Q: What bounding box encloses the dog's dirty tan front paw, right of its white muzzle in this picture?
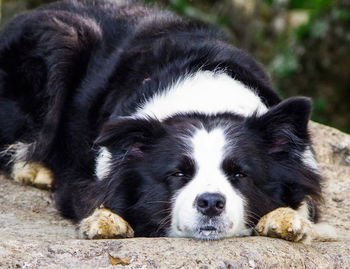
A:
[255,207,314,243]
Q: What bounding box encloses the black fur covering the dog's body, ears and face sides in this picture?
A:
[0,0,320,236]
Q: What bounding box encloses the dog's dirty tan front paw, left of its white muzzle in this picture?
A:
[79,208,134,239]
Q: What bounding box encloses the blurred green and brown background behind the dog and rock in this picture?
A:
[0,0,350,132]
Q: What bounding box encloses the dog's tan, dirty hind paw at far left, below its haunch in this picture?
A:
[11,162,53,189]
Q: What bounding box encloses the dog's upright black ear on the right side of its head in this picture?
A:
[246,97,312,154]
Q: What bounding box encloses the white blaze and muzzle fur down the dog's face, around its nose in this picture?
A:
[169,129,250,239]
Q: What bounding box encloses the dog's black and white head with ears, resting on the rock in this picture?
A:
[97,98,320,239]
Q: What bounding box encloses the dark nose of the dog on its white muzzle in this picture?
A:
[196,192,226,217]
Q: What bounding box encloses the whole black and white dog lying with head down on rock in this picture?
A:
[0,0,330,241]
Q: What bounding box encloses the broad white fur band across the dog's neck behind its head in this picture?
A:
[134,71,267,120]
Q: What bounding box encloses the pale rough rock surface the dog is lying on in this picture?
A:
[0,123,350,269]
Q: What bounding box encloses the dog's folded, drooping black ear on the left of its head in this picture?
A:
[95,118,166,156]
